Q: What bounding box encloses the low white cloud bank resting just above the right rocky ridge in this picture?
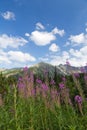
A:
[42,46,87,67]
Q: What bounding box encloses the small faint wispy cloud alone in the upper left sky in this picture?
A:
[1,11,15,20]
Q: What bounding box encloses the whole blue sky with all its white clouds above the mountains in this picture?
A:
[0,0,87,68]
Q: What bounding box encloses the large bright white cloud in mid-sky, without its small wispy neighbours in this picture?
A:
[30,31,56,46]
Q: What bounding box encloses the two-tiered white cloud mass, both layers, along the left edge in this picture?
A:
[0,34,36,68]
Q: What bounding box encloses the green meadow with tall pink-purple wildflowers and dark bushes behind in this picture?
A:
[0,67,87,130]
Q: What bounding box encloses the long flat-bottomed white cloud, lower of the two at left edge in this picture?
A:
[0,49,36,68]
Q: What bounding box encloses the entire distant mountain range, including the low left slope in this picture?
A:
[0,62,87,77]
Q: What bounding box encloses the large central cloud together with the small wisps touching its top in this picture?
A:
[27,22,65,46]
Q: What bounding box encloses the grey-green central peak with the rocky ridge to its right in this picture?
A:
[30,62,87,76]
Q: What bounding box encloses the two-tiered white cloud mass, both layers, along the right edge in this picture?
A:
[49,28,87,67]
